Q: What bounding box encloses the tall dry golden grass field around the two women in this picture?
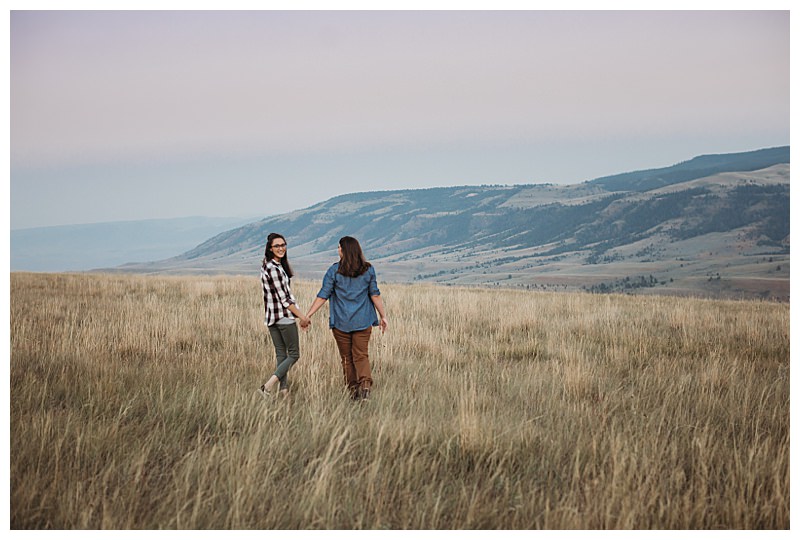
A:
[10,274,789,529]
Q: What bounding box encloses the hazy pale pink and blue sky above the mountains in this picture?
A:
[10,7,790,228]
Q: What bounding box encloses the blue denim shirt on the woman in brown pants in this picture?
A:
[317,263,381,332]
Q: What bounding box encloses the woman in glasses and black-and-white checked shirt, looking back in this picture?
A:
[261,233,311,396]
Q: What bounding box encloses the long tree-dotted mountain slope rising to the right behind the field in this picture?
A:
[118,147,789,299]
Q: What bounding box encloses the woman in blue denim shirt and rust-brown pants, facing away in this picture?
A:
[306,236,389,400]
